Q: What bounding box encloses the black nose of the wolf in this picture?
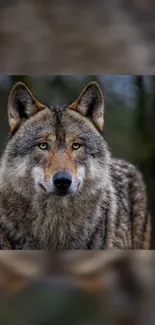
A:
[53,172,72,191]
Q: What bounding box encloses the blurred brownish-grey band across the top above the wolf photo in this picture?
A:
[0,0,155,74]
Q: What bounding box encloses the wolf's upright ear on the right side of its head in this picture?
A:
[70,82,104,131]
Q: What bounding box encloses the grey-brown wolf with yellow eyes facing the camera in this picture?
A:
[0,81,151,250]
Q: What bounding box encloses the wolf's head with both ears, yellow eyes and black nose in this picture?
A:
[2,82,109,197]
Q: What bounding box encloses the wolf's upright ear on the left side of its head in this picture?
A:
[8,82,44,132]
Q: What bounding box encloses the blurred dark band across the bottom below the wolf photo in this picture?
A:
[0,251,155,325]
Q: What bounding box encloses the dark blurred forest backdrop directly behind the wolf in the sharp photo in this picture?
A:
[0,75,155,249]
